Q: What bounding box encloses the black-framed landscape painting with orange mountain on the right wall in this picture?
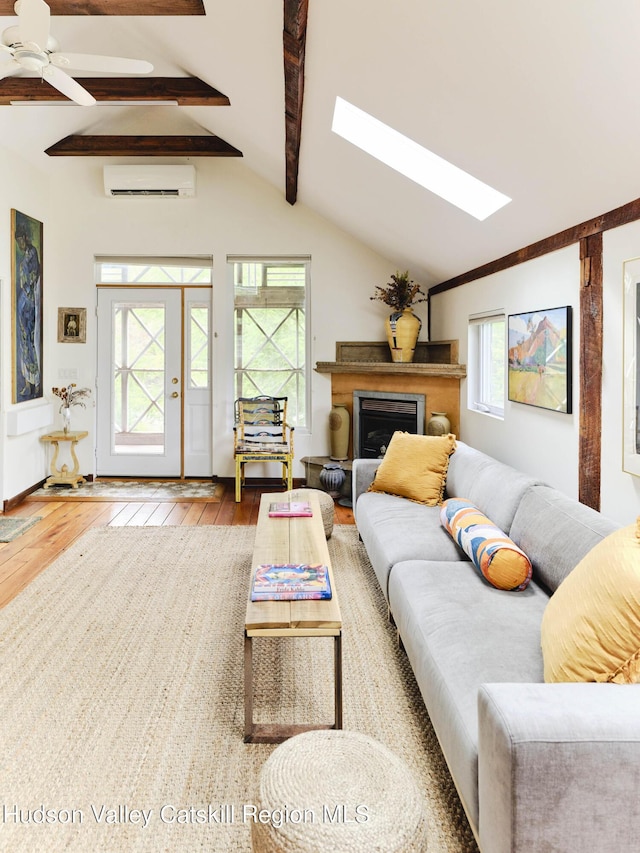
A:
[508,305,572,414]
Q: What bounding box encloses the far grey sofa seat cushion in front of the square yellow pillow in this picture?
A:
[356,492,469,599]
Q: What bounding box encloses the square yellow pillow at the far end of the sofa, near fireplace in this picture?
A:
[369,432,456,506]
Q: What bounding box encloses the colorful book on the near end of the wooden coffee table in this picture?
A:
[251,563,331,601]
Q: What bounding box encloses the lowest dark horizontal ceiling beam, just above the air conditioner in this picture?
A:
[45,134,242,157]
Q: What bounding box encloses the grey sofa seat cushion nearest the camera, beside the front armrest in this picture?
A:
[389,560,549,827]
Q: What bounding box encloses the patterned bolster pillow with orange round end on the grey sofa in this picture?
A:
[440,498,531,590]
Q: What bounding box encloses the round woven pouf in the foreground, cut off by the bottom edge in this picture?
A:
[251,729,427,853]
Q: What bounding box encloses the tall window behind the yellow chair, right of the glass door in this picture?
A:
[229,258,309,427]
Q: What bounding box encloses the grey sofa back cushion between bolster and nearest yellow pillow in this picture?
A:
[509,485,619,591]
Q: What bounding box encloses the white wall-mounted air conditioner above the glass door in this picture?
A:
[104,165,196,198]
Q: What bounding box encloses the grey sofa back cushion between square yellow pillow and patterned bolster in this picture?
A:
[445,441,539,536]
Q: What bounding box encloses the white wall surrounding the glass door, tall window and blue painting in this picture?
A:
[0,158,395,498]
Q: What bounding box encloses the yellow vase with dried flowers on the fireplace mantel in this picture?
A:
[370,270,427,362]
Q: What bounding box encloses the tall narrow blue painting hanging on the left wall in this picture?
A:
[11,210,43,403]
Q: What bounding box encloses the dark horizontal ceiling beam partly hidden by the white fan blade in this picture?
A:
[0,77,230,107]
